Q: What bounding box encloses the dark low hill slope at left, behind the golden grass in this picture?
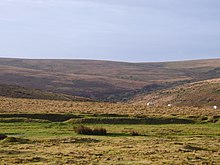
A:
[0,84,92,102]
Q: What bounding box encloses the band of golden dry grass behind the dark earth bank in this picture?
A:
[0,97,220,116]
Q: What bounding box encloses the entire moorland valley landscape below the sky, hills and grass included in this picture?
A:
[0,59,220,165]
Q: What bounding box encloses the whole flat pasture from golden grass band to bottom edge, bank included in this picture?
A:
[0,98,220,165]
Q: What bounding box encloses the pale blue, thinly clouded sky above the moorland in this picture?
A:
[0,0,220,62]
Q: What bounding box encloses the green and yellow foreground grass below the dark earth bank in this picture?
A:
[0,122,220,164]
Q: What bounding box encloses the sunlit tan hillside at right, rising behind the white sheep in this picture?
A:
[130,78,220,107]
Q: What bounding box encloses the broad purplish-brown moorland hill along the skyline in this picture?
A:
[0,58,220,101]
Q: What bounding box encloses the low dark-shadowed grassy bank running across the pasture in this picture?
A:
[0,113,220,124]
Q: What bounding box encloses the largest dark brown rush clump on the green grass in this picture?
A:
[74,125,107,135]
